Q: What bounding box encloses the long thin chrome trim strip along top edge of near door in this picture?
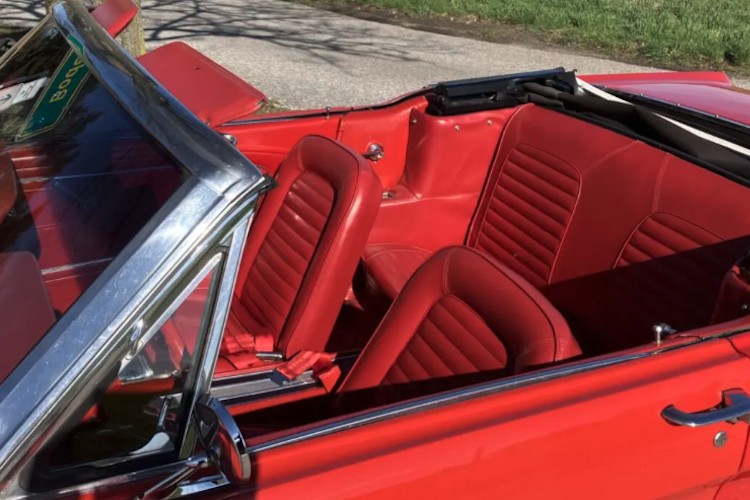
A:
[248,337,713,454]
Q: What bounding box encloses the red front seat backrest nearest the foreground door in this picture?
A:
[339,247,581,391]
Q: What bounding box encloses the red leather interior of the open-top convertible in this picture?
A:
[0,72,750,472]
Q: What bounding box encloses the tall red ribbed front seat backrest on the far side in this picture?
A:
[235,136,382,355]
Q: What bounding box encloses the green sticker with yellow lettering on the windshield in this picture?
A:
[18,50,89,139]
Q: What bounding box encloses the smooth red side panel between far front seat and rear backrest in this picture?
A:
[365,109,516,254]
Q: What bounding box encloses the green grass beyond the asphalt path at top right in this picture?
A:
[303,0,750,74]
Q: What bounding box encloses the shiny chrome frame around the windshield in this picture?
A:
[0,0,270,484]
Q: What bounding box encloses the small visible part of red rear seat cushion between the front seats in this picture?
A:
[362,245,432,300]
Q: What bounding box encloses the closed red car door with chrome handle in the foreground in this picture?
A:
[243,332,750,499]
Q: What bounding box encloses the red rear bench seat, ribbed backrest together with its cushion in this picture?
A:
[364,105,750,350]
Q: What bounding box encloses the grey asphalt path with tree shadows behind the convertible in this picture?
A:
[5,0,750,108]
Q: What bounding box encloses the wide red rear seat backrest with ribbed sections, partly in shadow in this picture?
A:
[467,106,750,354]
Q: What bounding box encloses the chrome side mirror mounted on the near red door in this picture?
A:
[139,396,250,500]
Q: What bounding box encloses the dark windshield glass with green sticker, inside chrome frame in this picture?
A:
[0,20,186,382]
